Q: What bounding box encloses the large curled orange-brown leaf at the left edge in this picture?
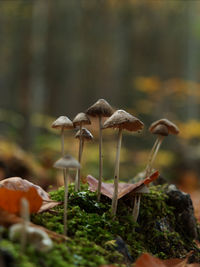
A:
[0,177,60,214]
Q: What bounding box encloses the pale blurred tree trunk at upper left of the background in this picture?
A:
[24,0,48,149]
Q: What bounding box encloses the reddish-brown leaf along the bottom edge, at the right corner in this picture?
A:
[133,253,200,267]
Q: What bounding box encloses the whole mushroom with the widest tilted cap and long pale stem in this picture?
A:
[103,110,144,215]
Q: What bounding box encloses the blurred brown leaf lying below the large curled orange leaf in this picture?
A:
[0,209,69,242]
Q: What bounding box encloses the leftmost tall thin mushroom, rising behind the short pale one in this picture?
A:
[51,116,74,187]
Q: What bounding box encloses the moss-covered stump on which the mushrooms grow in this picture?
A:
[0,185,200,267]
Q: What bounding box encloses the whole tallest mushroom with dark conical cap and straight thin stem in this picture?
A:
[86,99,113,201]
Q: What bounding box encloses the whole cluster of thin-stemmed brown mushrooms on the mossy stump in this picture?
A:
[52,99,179,234]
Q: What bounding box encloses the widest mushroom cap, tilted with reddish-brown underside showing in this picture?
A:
[103,109,144,132]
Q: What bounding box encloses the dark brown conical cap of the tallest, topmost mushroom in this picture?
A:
[85,99,113,117]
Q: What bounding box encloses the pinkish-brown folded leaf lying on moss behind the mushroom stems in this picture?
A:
[87,171,159,199]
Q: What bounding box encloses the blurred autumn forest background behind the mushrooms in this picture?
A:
[0,0,200,218]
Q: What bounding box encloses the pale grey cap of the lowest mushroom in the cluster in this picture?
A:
[53,155,81,169]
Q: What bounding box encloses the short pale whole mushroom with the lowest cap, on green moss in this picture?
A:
[54,155,80,235]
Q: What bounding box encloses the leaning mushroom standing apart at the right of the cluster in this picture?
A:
[145,119,179,177]
